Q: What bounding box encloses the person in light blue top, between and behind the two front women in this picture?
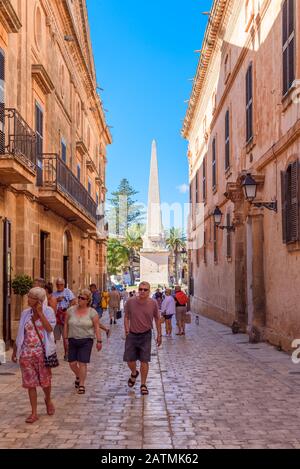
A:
[53,278,76,361]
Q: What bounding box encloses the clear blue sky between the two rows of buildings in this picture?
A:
[87,0,212,221]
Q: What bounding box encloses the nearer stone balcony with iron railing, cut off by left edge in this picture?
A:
[0,109,36,185]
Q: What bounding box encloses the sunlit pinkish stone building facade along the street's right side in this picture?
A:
[182,0,300,350]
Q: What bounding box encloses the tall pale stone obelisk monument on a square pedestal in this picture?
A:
[140,140,169,286]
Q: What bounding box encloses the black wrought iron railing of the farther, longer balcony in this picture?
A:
[38,153,97,223]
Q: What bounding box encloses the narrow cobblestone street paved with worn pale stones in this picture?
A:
[0,312,300,449]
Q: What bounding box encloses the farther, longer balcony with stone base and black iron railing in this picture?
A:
[38,154,97,231]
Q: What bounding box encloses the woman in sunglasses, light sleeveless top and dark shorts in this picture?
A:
[64,289,102,394]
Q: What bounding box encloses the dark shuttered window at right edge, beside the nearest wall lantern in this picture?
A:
[281,161,300,244]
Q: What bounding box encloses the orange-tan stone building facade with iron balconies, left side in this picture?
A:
[0,0,111,343]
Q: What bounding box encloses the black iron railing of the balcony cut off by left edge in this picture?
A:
[0,108,37,171]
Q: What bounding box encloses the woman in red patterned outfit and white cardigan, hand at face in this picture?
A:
[12,287,58,423]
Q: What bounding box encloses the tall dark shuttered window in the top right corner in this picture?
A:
[282,0,295,95]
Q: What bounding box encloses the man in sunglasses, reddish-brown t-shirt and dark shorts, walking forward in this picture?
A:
[124,282,161,396]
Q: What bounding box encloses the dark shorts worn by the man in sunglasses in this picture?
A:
[123,329,152,363]
